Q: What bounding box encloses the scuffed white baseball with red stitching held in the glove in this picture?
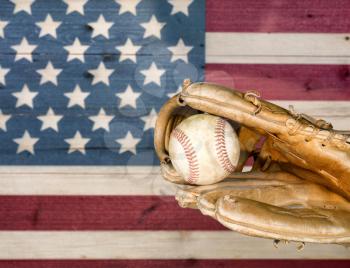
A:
[169,114,240,185]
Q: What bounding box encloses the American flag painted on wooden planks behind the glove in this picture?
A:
[0,0,350,268]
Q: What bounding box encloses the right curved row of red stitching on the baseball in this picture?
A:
[215,118,236,173]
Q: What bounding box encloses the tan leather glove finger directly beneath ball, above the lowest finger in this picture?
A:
[189,180,350,222]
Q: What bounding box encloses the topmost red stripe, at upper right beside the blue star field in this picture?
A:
[206,0,350,33]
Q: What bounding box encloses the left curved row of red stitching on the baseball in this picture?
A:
[171,129,199,183]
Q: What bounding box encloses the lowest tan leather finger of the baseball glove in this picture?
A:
[216,195,350,243]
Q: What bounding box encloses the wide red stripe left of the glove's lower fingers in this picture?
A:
[0,196,225,230]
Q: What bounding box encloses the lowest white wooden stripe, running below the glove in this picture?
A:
[0,231,350,260]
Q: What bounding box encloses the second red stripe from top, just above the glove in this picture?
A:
[206,64,350,100]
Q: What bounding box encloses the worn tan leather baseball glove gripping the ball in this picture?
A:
[154,80,350,244]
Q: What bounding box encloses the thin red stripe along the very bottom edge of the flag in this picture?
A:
[0,259,349,268]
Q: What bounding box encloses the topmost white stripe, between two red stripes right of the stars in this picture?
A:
[206,32,350,64]
